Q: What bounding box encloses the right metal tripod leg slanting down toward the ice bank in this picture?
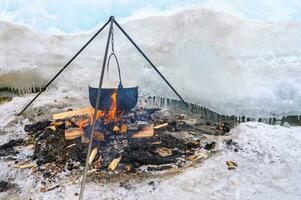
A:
[114,20,189,108]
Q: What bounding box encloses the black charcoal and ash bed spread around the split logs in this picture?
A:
[12,108,216,180]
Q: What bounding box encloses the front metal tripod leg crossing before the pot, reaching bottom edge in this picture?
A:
[79,16,114,200]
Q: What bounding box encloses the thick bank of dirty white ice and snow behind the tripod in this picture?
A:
[0,9,301,115]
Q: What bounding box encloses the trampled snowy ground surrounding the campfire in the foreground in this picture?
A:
[0,92,301,199]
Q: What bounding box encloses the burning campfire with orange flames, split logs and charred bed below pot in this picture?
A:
[12,91,229,184]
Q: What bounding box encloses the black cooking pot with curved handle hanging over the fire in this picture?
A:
[89,53,138,112]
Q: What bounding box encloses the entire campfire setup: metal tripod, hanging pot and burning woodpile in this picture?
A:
[7,16,229,199]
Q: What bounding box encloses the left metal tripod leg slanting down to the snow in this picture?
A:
[18,20,110,116]
